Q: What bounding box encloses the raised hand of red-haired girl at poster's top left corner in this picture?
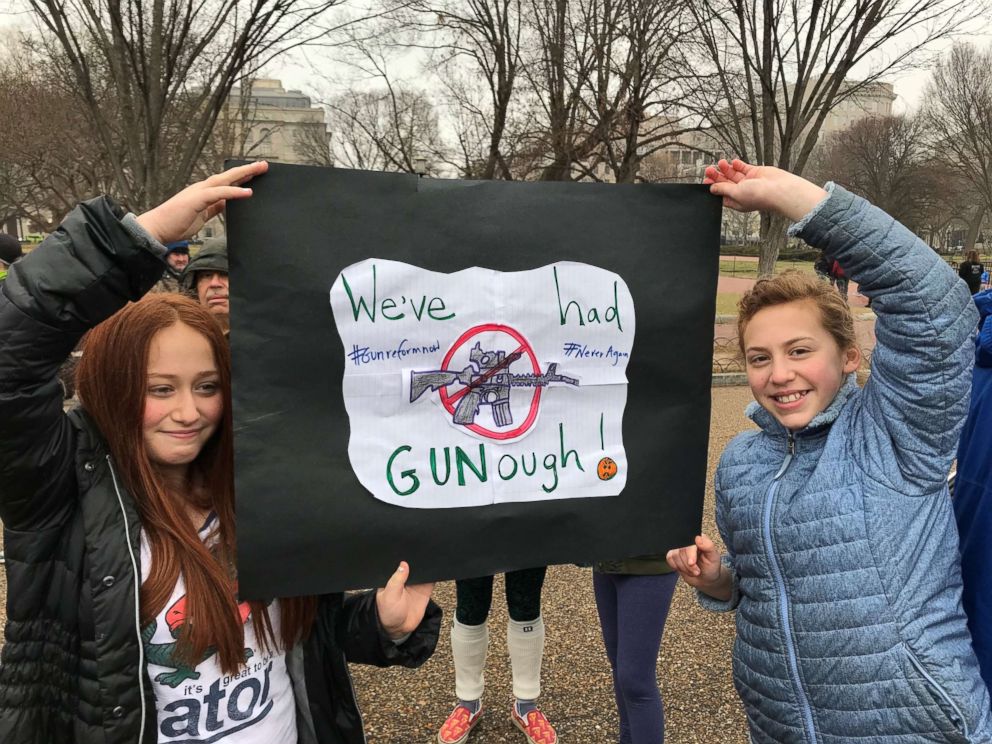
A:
[138,160,269,243]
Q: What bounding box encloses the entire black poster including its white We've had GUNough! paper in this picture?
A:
[228,166,720,597]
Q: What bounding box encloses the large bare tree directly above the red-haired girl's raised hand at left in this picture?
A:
[29,0,356,209]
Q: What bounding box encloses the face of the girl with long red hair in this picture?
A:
[142,322,224,477]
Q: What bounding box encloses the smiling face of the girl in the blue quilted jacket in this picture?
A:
[744,300,861,431]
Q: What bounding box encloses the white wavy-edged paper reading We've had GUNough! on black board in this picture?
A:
[330,258,634,508]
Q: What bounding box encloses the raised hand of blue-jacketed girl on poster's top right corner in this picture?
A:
[703,159,827,221]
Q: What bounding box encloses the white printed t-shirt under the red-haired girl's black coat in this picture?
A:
[141,517,296,744]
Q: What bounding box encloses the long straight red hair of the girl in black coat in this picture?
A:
[76,294,316,674]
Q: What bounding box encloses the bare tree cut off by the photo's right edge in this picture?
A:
[924,44,992,250]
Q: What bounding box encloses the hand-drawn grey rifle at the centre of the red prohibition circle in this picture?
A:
[410,343,579,427]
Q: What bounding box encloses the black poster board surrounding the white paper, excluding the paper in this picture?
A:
[227,165,721,597]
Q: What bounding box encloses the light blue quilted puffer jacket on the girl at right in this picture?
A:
[699,186,992,744]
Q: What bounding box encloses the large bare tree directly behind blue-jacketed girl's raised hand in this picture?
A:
[689,0,988,276]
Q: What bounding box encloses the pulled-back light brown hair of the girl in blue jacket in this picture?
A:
[737,270,857,354]
